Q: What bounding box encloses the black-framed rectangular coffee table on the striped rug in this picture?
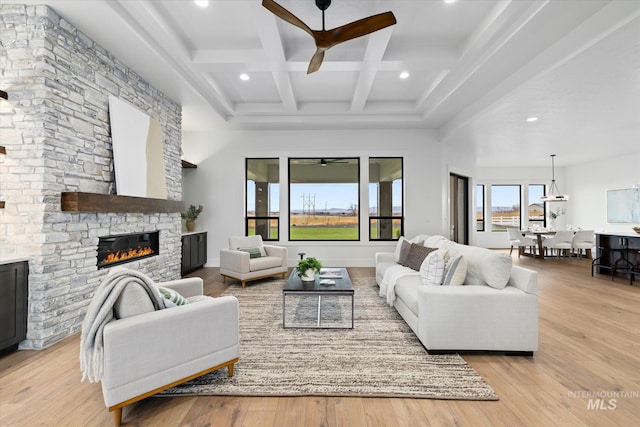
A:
[282,268,354,329]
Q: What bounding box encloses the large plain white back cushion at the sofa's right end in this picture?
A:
[455,245,513,289]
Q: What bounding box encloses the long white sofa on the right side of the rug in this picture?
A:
[375,235,538,355]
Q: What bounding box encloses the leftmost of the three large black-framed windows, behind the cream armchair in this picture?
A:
[245,159,280,240]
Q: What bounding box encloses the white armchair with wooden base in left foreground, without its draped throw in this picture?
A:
[102,278,239,426]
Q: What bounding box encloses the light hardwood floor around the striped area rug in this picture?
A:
[0,254,640,427]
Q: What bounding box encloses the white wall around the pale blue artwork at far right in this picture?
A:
[566,153,640,233]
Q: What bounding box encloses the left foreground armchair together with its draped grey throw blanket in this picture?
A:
[80,269,240,426]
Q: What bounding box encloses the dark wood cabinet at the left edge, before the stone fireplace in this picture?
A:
[0,261,29,355]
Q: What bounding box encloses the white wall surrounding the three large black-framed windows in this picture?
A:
[183,130,448,266]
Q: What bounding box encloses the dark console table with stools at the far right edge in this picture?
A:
[594,232,640,282]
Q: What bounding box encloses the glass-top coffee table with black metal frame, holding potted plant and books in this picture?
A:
[282,268,354,329]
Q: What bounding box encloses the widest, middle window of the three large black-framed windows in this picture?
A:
[289,158,360,240]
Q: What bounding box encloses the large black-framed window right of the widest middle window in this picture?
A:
[369,157,404,240]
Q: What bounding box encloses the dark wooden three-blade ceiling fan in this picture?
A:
[262,0,396,74]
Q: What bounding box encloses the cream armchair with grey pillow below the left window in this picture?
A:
[220,235,288,288]
